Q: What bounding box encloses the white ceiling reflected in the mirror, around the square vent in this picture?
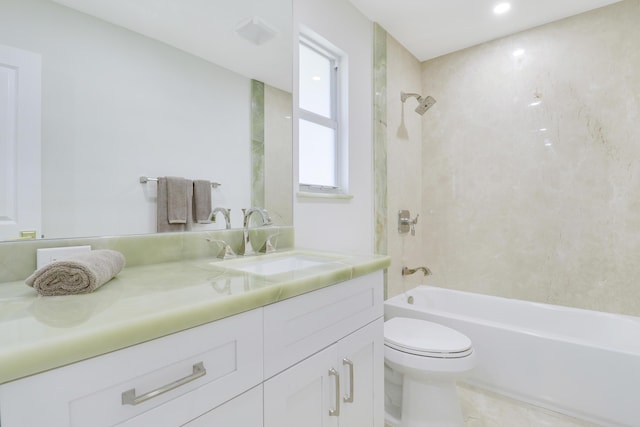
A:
[52,0,293,92]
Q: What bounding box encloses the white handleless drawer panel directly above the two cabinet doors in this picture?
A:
[264,272,383,378]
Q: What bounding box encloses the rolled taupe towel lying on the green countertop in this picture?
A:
[25,249,125,296]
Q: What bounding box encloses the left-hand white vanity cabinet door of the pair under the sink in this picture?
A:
[264,345,340,427]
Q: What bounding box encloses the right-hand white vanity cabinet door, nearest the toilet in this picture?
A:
[337,319,384,427]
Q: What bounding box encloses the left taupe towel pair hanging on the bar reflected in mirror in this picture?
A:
[156,177,193,233]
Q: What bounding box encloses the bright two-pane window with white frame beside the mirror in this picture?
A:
[298,37,343,193]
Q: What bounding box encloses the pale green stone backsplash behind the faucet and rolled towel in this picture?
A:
[0,226,294,283]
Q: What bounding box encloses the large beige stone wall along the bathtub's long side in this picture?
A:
[418,0,640,315]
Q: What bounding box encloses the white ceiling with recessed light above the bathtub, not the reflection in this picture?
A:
[350,0,620,61]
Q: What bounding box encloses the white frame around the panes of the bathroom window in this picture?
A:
[297,34,346,195]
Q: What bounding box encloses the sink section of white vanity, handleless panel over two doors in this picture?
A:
[264,273,384,427]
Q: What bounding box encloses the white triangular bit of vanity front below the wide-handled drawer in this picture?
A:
[184,385,262,427]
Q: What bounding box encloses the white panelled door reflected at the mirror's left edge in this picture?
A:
[0,45,41,241]
